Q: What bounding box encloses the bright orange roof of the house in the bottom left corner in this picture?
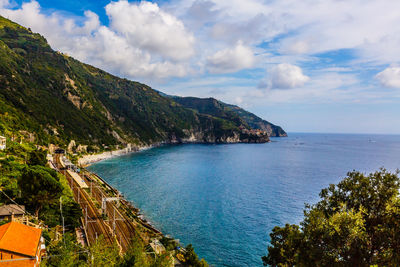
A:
[0,222,42,257]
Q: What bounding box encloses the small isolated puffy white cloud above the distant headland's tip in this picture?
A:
[268,63,310,89]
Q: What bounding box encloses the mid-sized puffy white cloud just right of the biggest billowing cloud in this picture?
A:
[207,42,255,73]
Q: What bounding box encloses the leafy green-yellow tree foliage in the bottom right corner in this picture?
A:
[263,169,400,266]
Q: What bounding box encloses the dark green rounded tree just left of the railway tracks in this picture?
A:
[18,166,63,217]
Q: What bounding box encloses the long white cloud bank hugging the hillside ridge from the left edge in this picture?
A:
[0,0,194,79]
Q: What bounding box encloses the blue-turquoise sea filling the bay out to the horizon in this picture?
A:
[89,133,400,266]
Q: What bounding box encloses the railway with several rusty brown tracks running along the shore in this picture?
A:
[55,155,160,253]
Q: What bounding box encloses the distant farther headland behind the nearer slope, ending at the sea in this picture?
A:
[172,96,287,137]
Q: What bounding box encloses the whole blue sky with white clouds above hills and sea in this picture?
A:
[0,0,400,134]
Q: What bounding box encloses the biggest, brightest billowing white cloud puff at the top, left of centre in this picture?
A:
[106,1,194,61]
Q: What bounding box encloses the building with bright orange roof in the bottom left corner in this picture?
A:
[0,222,45,267]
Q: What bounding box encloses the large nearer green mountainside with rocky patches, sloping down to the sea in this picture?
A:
[0,17,284,149]
